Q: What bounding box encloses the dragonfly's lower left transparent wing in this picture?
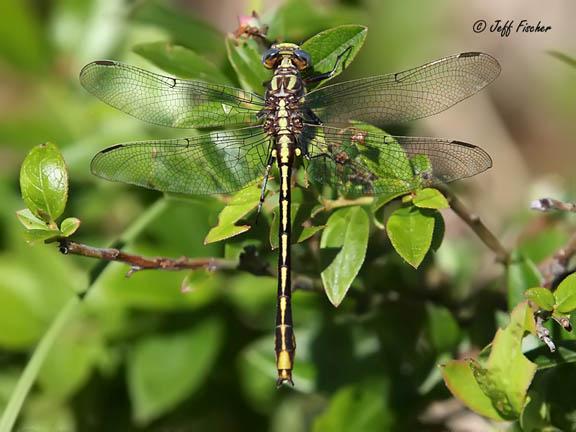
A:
[91,126,270,195]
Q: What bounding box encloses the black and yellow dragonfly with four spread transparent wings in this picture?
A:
[80,43,500,386]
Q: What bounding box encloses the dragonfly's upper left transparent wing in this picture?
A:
[80,60,264,128]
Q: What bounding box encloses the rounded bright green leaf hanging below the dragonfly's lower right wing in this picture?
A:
[386,206,435,268]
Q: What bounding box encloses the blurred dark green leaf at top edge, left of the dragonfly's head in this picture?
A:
[131,2,224,60]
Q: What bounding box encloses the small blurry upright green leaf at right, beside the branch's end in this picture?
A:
[506,251,541,310]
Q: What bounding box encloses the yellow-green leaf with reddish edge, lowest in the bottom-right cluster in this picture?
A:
[442,360,504,420]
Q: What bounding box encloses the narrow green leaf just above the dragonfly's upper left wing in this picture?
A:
[132,42,230,84]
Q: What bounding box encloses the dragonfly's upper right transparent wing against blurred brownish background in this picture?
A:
[305,52,500,125]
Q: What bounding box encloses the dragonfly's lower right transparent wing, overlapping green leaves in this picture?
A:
[301,122,492,196]
